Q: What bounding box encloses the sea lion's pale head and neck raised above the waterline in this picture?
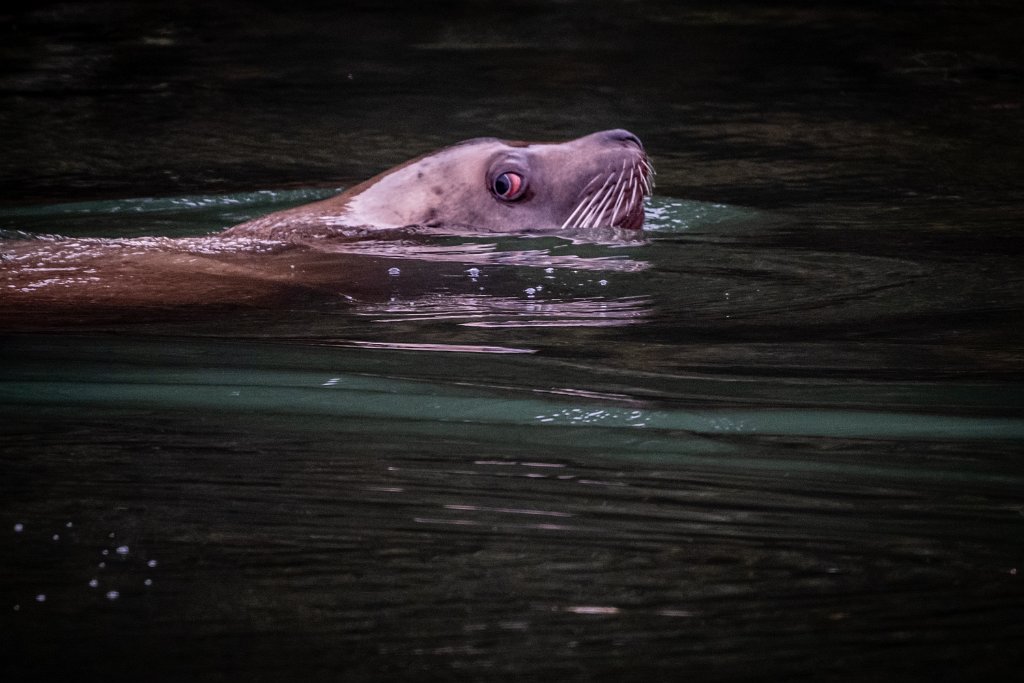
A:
[221,129,653,240]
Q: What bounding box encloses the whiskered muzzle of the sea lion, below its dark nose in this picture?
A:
[560,150,654,230]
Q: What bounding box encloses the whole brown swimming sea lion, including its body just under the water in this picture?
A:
[0,130,653,329]
